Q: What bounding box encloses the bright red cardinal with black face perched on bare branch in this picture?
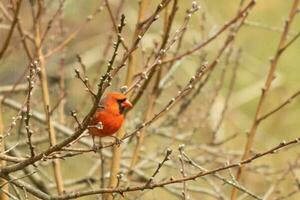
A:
[88,92,132,147]
